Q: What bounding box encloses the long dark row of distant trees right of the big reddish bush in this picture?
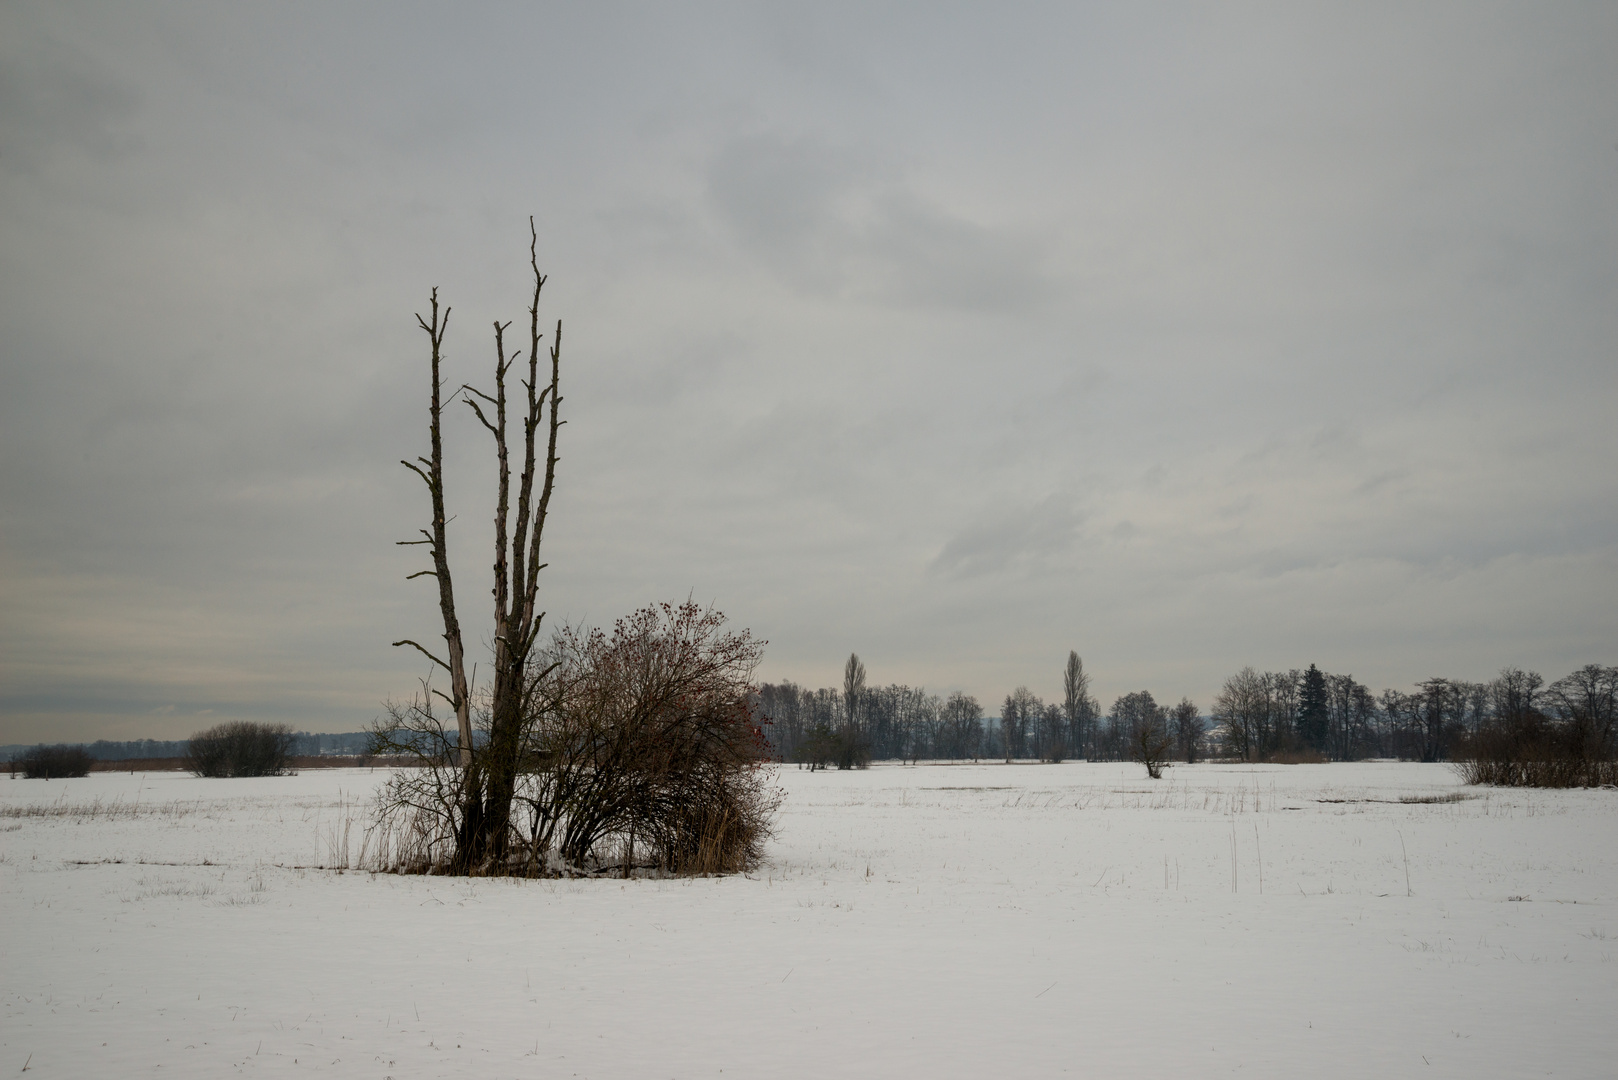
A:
[756,653,1618,780]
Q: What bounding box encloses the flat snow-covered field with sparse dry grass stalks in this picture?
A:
[0,764,1618,1078]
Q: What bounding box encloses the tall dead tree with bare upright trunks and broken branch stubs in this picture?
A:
[393,219,561,873]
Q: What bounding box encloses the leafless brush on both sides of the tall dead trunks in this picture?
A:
[371,602,778,876]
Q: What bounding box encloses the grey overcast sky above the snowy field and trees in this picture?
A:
[0,0,1618,742]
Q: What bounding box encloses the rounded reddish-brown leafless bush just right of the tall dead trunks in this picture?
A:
[519,602,775,873]
